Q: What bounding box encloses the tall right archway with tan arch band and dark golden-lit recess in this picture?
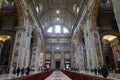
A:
[91,0,120,70]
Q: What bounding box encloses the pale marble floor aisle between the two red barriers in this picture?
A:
[45,70,72,80]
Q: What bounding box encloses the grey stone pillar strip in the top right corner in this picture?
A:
[112,0,120,32]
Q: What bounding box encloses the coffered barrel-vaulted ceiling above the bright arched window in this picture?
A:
[35,0,83,37]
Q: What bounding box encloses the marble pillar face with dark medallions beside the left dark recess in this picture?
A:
[10,27,24,73]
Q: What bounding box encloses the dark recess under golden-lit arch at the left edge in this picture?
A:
[0,31,15,73]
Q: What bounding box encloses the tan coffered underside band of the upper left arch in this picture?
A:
[13,0,25,26]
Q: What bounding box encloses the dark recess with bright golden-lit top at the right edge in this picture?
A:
[100,31,120,72]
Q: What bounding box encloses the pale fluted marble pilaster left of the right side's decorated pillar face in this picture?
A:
[84,26,97,69]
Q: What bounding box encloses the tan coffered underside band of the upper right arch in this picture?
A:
[91,0,102,27]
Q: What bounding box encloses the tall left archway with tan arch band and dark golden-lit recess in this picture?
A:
[0,0,24,72]
